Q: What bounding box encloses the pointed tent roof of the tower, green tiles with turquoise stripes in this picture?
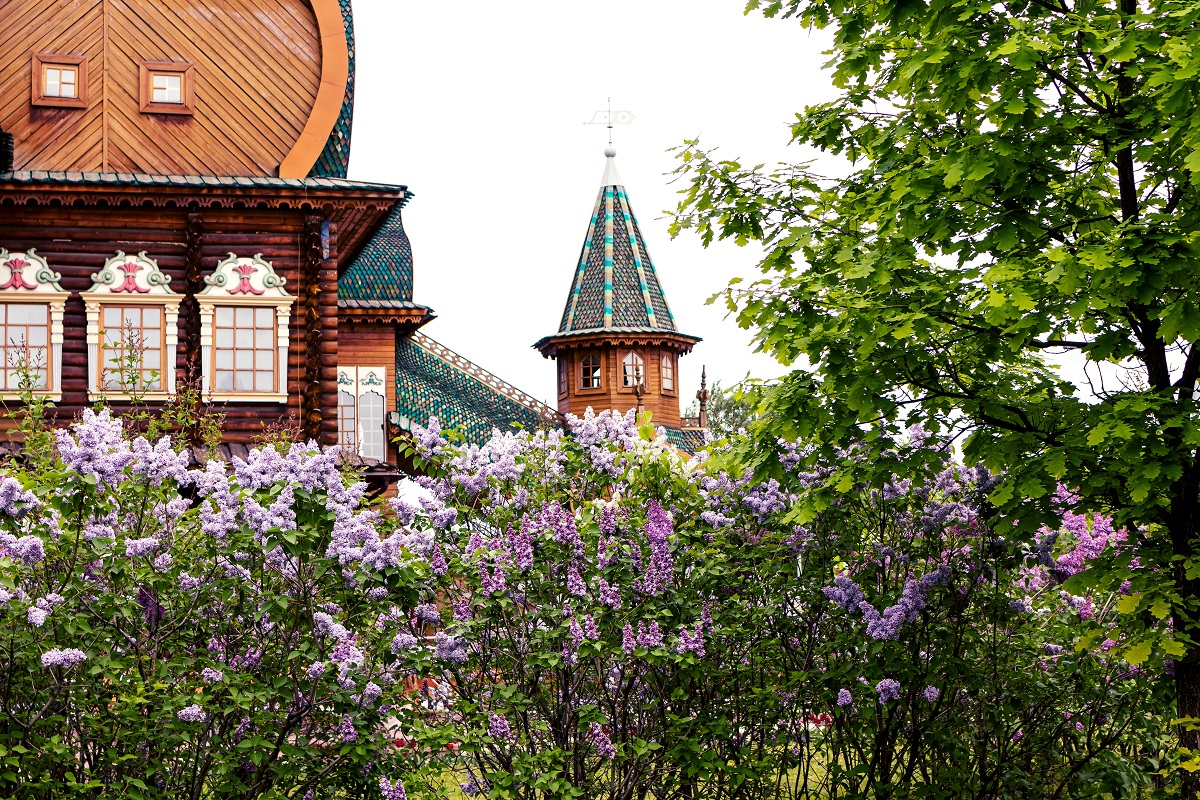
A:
[558,146,677,336]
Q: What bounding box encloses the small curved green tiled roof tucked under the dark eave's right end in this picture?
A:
[337,203,418,308]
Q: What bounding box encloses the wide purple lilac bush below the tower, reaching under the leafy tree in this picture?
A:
[392,413,1170,800]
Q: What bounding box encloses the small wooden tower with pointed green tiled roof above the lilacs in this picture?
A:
[534,146,700,431]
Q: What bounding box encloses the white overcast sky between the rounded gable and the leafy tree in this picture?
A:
[350,0,833,407]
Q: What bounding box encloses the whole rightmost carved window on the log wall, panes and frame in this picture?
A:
[196,254,295,403]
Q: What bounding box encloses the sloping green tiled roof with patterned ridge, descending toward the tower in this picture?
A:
[396,332,560,444]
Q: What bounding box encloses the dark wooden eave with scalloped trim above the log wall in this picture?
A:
[0,173,408,272]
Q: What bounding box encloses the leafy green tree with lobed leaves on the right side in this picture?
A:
[674,0,1200,777]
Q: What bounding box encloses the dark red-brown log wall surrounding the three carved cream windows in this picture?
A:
[0,205,338,444]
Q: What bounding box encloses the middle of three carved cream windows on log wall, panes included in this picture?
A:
[83,251,181,401]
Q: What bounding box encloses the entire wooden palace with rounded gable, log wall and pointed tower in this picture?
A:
[0,0,697,463]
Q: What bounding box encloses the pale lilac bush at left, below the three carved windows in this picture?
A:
[0,411,431,799]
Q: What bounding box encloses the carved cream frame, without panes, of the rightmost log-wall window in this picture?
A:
[196,253,296,403]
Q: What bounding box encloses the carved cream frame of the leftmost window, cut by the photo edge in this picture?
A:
[0,247,71,401]
